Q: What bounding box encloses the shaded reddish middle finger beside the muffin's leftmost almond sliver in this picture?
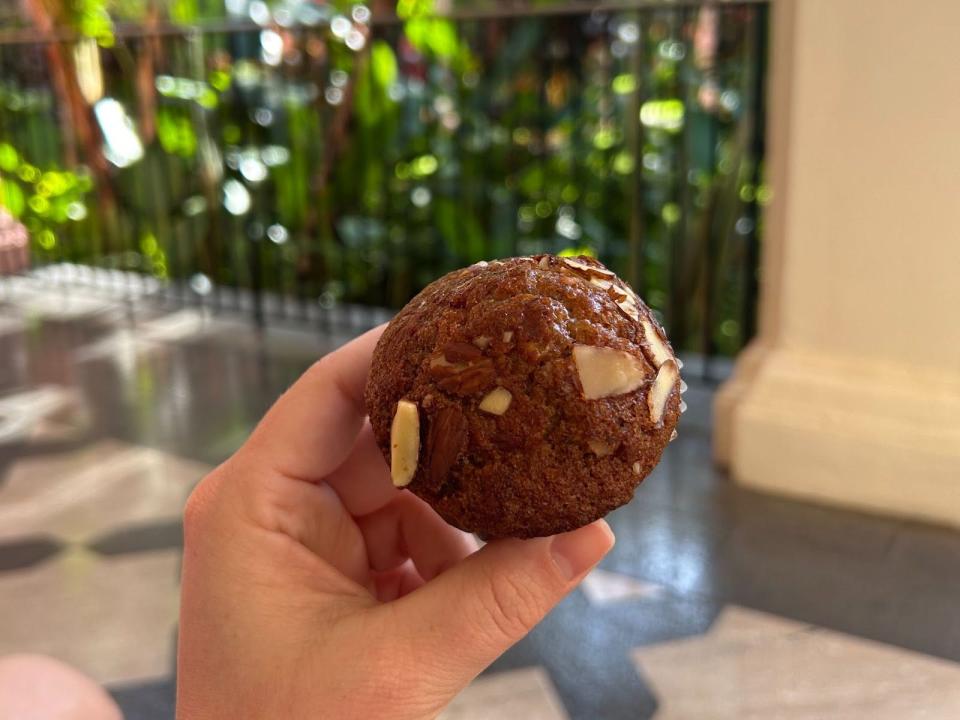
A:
[326,422,400,516]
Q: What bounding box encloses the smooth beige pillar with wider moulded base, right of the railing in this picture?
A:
[714,0,960,526]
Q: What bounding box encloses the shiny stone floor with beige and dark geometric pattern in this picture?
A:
[0,284,960,720]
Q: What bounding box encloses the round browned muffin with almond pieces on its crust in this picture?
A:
[366,255,681,538]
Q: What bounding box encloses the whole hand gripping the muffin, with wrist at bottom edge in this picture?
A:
[177,330,613,720]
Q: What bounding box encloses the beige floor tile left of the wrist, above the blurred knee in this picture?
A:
[0,548,180,683]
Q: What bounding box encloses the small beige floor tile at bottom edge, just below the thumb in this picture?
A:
[438,667,567,720]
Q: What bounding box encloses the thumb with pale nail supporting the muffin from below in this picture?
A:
[393,520,614,697]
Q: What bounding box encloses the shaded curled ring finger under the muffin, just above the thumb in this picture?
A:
[356,492,477,580]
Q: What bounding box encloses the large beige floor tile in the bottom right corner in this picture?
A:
[633,606,960,720]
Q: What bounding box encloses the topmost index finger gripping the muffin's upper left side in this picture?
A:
[239,326,384,481]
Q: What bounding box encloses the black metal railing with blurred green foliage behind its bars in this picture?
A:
[0,3,769,372]
